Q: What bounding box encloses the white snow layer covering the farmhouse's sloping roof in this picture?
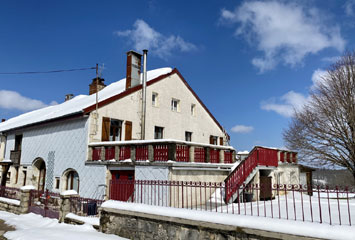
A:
[0,68,172,132]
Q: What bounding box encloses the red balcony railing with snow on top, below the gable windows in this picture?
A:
[88,139,235,164]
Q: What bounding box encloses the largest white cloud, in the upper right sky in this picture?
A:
[221,1,345,72]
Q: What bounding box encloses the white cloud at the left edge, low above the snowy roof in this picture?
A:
[0,90,57,111]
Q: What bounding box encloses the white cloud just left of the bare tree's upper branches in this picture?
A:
[261,91,308,117]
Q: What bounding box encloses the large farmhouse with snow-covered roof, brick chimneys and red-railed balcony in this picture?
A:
[0,51,235,198]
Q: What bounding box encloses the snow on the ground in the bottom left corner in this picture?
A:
[0,211,126,240]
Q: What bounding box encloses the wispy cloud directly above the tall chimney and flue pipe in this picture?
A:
[114,19,197,59]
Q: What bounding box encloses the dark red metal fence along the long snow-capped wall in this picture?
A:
[110,180,355,226]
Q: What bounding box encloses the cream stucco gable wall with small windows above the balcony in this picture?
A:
[90,74,224,144]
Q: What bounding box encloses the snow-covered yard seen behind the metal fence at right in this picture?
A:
[207,189,355,228]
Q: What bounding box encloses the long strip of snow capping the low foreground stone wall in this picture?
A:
[102,200,355,240]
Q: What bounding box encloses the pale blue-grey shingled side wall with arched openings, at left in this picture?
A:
[5,118,105,198]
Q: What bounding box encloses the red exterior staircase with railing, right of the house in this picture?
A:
[224,146,280,203]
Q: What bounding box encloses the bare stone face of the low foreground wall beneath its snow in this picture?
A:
[100,207,315,240]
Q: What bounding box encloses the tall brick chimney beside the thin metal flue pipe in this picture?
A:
[126,50,142,90]
